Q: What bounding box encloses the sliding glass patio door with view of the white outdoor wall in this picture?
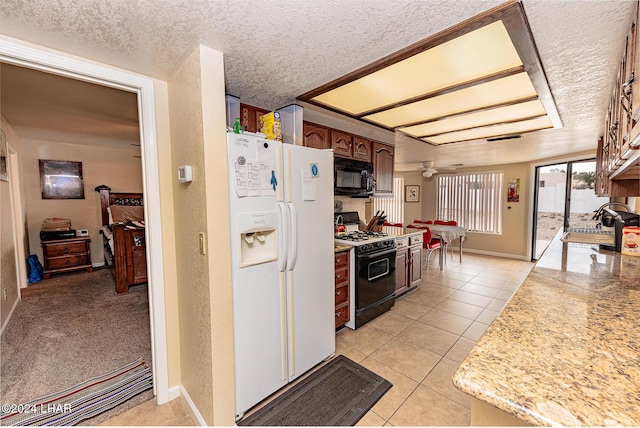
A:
[531,159,609,261]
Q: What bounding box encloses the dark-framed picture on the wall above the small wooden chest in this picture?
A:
[38,159,84,199]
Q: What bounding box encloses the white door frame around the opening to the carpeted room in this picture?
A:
[0,37,169,404]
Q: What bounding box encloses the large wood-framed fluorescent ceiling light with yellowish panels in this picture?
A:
[298,1,562,145]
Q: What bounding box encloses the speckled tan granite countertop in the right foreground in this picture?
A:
[453,233,640,426]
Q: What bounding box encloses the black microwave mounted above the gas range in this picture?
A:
[333,156,374,198]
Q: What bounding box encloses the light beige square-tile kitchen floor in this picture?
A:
[102,254,533,426]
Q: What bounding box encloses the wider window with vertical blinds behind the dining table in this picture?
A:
[436,172,503,234]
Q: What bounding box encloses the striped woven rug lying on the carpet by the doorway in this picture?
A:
[0,358,153,426]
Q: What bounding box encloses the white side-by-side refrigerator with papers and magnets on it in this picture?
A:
[227,133,335,417]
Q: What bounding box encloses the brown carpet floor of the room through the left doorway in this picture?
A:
[0,269,153,425]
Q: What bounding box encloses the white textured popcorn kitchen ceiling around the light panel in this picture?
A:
[0,0,636,168]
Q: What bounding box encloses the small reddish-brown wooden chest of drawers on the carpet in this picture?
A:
[41,238,93,279]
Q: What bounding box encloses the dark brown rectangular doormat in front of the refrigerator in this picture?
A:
[238,355,393,426]
